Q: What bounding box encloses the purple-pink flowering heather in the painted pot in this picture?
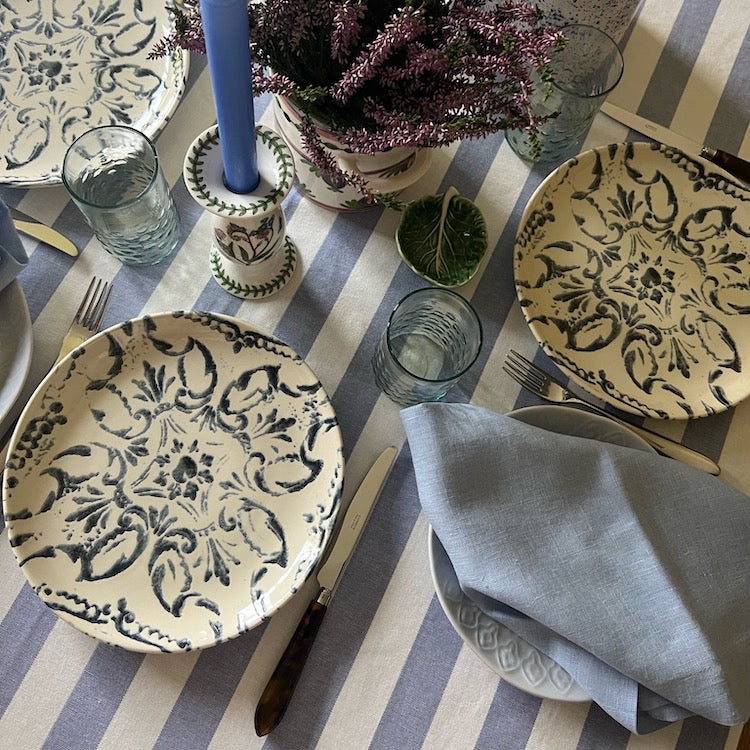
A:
[153,0,563,198]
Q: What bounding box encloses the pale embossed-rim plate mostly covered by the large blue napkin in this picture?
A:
[428,406,652,702]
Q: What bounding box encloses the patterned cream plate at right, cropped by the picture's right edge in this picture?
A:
[514,143,750,419]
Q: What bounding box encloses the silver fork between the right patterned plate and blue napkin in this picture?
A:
[503,349,721,475]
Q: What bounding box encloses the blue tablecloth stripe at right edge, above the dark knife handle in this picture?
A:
[706,25,750,154]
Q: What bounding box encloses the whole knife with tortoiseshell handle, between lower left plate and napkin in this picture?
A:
[255,446,396,737]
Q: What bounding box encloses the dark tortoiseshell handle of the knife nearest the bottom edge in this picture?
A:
[255,588,331,737]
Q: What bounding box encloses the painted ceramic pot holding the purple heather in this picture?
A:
[273,97,432,211]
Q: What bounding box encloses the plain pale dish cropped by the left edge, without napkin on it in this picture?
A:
[0,281,34,438]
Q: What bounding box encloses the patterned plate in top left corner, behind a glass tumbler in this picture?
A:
[0,0,189,186]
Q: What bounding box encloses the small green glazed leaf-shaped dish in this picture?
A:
[396,188,487,287]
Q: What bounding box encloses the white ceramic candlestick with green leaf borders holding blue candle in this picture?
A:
[183,125,297,299]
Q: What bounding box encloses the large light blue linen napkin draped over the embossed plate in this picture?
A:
[401,403,750,734]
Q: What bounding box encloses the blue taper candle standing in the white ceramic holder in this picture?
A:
[200,0,260,193]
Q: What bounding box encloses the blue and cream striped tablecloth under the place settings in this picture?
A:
[0,0,750,750]
